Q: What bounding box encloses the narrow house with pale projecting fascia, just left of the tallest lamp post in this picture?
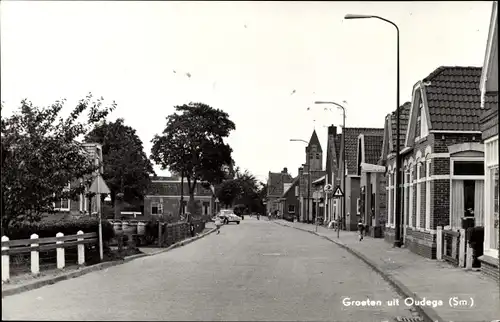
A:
[356,134,385,237]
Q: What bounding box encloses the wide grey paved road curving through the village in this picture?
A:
[2,218,418,322]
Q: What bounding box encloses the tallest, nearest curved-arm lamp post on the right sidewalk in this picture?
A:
[344,14,402,247]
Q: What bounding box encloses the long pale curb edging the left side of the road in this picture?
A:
[2,228,217,298]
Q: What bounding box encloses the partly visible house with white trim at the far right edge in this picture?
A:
[479,1,500,280]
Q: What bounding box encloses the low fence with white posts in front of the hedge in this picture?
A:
[2,230,98,282]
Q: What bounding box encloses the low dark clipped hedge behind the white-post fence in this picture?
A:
[6,218,115,242]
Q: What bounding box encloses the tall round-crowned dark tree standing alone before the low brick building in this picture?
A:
[151,103,236,215]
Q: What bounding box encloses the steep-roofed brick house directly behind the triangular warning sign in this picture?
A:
[336,128,384,231]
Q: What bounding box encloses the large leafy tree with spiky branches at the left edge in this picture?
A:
[1,94,116,230]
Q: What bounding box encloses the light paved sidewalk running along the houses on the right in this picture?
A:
[275,220,500,322]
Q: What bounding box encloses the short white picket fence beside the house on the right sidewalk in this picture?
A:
[436,226,473,269]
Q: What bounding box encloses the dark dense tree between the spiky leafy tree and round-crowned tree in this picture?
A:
[85,119,154,204]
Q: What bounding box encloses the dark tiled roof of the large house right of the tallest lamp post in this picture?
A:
[420,66,482,131]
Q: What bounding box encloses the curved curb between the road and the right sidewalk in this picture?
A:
[275,222,444,322]
